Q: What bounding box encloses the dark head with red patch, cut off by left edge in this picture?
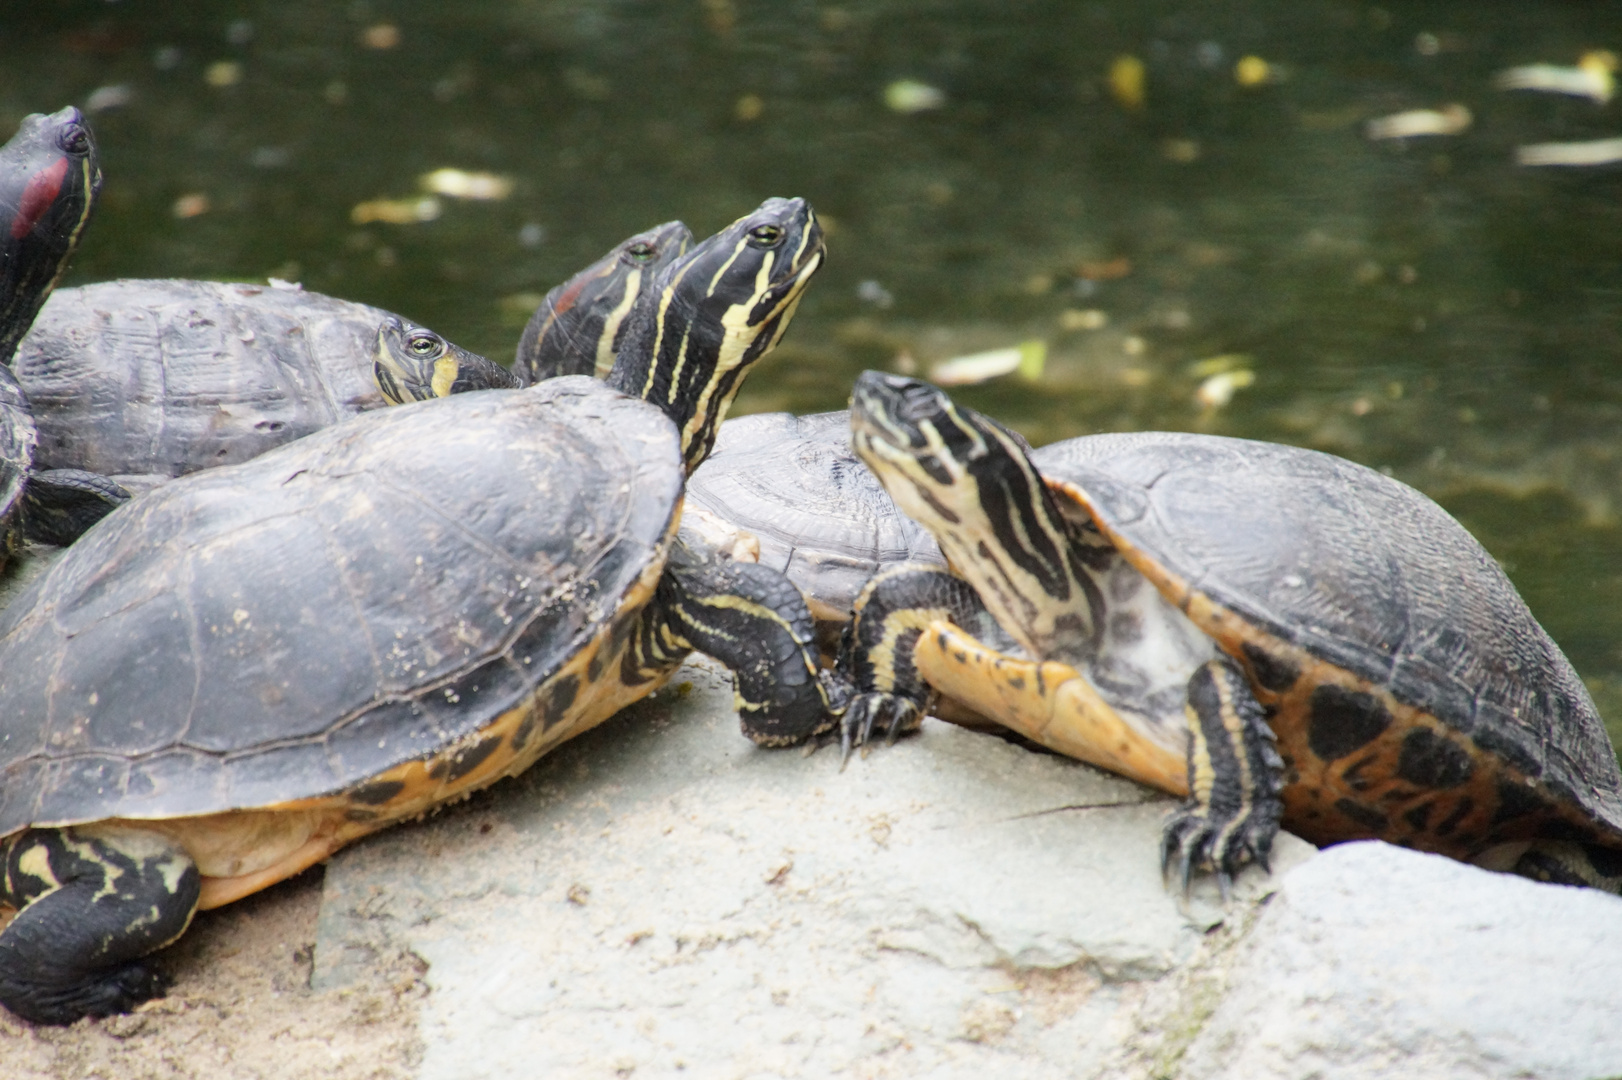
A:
[0,105,101,363]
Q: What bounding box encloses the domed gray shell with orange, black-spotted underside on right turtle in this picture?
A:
[1032,433,1622,846]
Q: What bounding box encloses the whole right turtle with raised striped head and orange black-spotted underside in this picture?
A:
[840,371,1622,892]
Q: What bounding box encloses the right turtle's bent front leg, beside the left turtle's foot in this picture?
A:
[835,563,1014,759]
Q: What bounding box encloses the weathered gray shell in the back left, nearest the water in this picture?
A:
[13,279,389,490]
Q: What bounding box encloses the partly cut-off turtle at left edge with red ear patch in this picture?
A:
[0,105,128,563]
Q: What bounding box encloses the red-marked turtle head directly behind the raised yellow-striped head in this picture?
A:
[513,221,693,386]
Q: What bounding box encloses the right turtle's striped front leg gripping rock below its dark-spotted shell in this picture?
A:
[1160,657,1285,900]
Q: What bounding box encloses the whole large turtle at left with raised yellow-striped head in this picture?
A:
[0,199,837,1023]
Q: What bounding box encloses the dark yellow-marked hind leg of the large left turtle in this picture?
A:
[0,825,201,1023]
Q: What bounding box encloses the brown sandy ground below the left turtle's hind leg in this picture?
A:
[0,869,427,1080]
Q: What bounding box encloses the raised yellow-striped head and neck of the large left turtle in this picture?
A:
[608,199,822,474]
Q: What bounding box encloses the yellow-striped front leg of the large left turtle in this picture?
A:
[647,540,837,746]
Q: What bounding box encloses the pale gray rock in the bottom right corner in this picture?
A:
[1178,843,1622,1080]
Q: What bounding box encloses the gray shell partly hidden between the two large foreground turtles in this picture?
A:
[686,412,946,619]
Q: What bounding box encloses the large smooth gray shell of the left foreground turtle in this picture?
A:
[0,378,683,835]
